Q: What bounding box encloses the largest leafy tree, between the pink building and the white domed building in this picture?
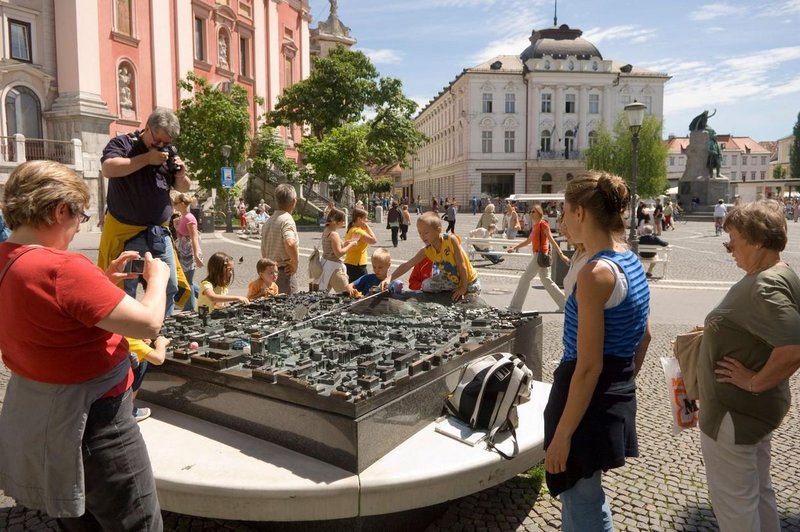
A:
[267,46,425,188]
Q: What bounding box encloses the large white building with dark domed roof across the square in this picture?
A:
[401,25,669,205]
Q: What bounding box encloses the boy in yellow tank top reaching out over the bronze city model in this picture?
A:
[381,212,481,301]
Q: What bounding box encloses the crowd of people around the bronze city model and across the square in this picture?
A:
[0,109,800,531]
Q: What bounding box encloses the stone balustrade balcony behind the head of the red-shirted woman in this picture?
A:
[0,134,83,173]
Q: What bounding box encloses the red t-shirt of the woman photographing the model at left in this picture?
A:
[0,242,133,395]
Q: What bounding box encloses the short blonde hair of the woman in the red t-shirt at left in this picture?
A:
[3,161,90,230]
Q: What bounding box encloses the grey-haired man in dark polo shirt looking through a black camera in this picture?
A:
[97,107,191,316]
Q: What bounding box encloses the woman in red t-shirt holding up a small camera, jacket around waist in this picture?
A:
[0,161,170,530]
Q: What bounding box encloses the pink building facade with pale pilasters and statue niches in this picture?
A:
[0,0,311,224]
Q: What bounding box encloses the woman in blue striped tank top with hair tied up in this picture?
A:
[544,172,650,532]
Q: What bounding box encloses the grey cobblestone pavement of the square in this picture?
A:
[0,217,800,532]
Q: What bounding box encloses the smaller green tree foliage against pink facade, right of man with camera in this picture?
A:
[175,72,250,196]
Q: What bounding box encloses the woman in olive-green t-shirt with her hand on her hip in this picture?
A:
[697,201,800,532]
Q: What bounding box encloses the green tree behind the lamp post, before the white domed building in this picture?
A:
[586,113,668,197]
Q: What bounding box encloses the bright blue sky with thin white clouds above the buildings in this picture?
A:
[309,0,800,141]
